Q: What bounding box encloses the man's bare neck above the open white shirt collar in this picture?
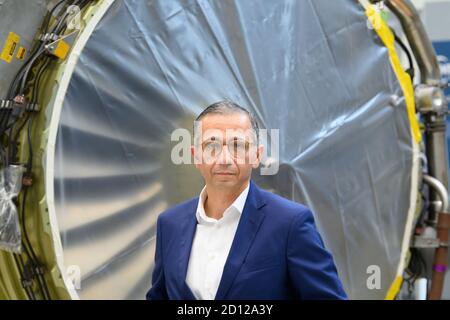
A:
[203,181,249,220]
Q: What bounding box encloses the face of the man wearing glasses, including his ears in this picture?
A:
[191,113,263,189]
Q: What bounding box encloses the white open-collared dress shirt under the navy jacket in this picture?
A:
[186,184,250,300]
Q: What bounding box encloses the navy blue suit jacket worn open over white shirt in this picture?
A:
[147,181,346,300]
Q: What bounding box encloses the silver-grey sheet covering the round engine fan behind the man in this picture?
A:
[54,0,415,299]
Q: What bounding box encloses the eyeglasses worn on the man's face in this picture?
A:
[202,137,252,159]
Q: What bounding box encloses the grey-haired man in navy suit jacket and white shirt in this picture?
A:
[147,101,346,300]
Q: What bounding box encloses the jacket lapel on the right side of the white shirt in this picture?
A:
[216,181,265,300]
